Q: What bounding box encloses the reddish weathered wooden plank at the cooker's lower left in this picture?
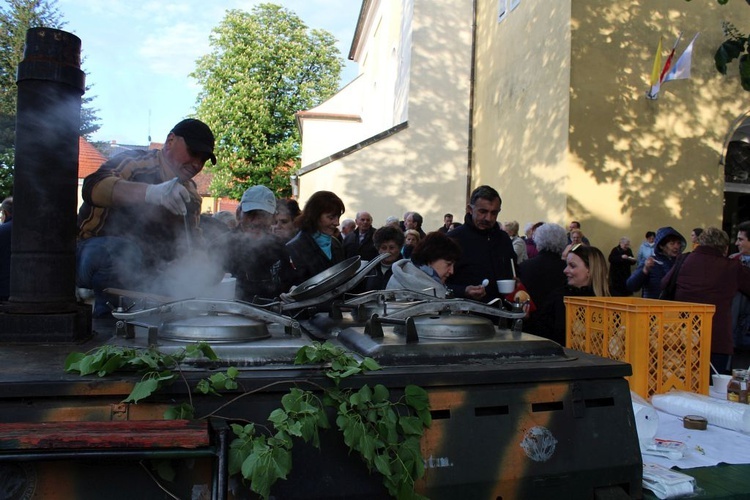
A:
[0,420,210,450]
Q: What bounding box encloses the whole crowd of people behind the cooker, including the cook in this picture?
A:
[0,119,750,372]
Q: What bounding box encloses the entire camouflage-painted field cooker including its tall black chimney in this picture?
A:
[0,28,642,500]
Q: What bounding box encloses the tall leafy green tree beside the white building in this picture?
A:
[191,4,343,199]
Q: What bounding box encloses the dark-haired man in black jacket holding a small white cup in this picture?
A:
[447,186,516,302]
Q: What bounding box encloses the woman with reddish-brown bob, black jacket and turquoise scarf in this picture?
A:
[286,191,344,284]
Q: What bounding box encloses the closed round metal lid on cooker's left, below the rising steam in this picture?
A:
[159,314,271,342]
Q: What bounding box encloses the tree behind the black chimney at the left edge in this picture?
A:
[0,0,99,197]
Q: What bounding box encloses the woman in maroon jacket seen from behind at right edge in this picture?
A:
[661,227,750,373]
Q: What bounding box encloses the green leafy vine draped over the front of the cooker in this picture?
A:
[65,342,431,499]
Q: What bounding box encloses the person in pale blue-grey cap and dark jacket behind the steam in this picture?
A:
[216,186,294,303]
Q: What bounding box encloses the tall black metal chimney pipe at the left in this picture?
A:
[0,28,91,341]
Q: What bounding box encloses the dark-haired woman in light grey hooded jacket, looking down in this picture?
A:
[386,232,461,299]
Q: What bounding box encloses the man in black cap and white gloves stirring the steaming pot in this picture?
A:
[76,118,216,318]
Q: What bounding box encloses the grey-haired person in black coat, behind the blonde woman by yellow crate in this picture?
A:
[518,223,568,344]
